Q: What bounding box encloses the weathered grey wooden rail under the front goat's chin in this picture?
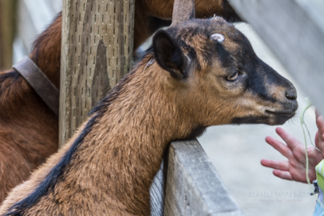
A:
[164,140,242,216]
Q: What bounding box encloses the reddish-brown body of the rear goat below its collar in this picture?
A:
[0,71,58,201]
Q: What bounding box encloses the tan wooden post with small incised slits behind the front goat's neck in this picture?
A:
[59,0,134,146]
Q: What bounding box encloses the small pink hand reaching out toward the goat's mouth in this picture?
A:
[261,126,324,183]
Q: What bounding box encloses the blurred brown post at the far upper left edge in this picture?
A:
[0,0,16,70]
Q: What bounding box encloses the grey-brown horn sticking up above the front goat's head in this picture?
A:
[171,0,195,25]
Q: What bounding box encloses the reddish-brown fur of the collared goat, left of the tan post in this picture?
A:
[0,13,61,203]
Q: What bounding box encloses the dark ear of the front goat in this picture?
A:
[153,30,188,79]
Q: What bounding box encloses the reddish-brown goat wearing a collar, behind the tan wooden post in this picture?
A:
[0,0,239,203]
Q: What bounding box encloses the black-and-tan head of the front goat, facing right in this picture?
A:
[153,17,297,126]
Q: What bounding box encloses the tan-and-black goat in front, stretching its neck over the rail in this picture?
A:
[0,11,297,215]
